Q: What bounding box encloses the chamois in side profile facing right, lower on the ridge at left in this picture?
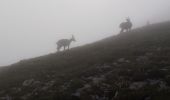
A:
[56,35,76,51]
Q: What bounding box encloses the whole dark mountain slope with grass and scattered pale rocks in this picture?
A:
[0,22,170,100]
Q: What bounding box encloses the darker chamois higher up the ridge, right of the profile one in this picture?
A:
[120,18,132,33]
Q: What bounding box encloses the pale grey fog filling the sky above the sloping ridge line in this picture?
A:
[0,0,170,66]
